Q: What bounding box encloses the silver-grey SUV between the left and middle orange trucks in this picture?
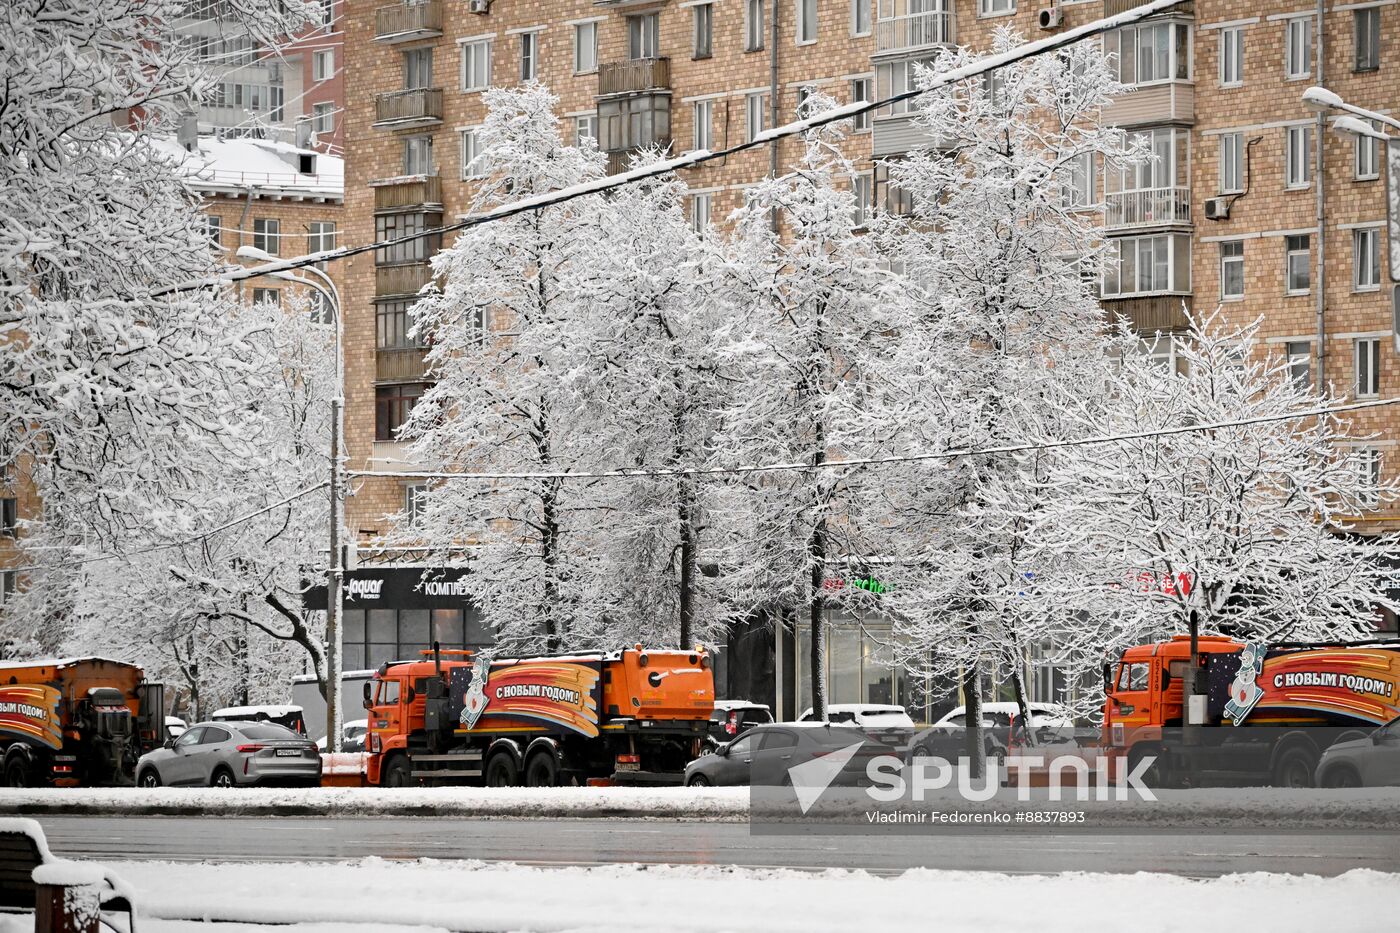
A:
[136,721,321,787]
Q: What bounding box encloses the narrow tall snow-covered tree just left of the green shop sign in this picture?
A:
[713,98,902,719]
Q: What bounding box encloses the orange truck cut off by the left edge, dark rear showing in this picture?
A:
[0,657,165,787]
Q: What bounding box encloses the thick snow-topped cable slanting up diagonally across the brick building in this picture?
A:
[151,0,1187,297]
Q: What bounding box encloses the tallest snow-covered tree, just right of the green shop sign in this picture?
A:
[881,28,1127,759]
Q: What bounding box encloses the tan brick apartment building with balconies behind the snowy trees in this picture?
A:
[343,0,1400,714]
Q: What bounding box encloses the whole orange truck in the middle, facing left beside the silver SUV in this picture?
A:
[364,644,714,787]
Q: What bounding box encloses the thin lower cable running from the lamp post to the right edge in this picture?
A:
[346,396,1400,481]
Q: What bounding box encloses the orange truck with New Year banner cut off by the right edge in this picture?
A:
[1102,636,1400,787]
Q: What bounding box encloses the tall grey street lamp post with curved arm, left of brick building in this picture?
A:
[237,247,346,752]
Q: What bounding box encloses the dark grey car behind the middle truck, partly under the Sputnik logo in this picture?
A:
[685,723,889,787]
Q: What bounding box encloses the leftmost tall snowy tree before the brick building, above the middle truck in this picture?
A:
[403,85,609,651]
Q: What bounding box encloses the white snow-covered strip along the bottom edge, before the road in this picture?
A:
[19,859,1400,933]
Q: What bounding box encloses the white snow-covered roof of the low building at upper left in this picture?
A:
[150,136,344,199]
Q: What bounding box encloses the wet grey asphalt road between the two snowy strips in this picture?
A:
[36,815,1400,877]
